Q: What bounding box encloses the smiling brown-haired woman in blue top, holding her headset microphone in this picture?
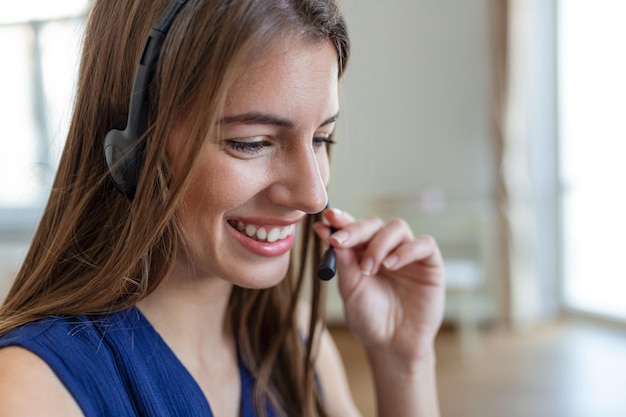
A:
[0,0,443,417]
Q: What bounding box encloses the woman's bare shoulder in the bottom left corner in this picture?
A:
[0,346,83,417]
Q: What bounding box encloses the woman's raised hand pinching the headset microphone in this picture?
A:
[315,209,444,365]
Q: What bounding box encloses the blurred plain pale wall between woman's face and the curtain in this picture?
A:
[331,0,494,215]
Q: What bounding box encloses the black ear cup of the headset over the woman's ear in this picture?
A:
[104,116,143,200]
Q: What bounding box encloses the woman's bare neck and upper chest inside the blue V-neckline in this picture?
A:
[137,268,241,416]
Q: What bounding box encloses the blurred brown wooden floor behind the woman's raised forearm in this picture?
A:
[331,318,626,417]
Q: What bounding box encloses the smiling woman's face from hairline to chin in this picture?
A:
[170,39,339,288]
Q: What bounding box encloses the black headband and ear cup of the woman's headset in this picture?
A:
[104,0,187,200]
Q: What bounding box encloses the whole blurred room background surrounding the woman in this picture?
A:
[0,0,626,417]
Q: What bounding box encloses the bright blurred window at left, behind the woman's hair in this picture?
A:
[0,0,90,223]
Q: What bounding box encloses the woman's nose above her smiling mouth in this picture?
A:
[269,146,329,214]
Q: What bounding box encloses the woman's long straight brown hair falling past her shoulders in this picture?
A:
[0,0,349,416]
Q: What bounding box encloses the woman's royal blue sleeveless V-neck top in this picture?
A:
[0,307,276,417]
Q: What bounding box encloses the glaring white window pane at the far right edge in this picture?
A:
[559,0,626,319]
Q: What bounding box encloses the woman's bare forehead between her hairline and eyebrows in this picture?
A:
[225,38,339,120]
